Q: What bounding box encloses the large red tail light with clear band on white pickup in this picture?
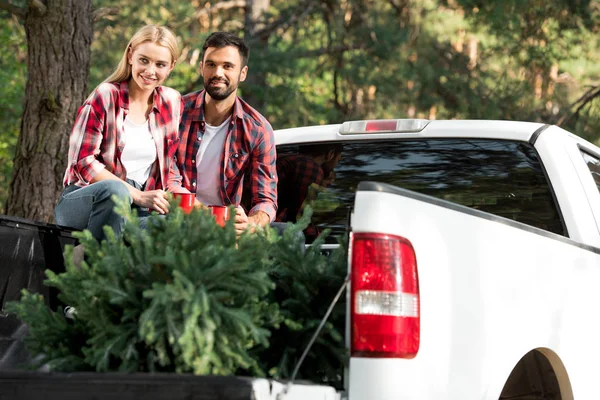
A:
[350,233,421,358]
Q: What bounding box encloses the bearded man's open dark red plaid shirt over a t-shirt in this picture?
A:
[171,90,277,221]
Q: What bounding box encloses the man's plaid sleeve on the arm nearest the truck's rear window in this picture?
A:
[247,122,277,222]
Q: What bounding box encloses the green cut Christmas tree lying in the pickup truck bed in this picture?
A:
[8,197,346,388]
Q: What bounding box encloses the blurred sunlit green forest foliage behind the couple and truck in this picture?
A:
[0,0,600,207]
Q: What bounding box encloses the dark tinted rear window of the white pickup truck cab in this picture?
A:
[270,139,565,243]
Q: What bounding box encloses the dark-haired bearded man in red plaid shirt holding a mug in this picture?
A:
[170,32,277,234]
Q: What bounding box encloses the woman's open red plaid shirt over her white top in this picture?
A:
[63,81,183,190]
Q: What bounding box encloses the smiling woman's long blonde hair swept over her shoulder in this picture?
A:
[104,25,179,82]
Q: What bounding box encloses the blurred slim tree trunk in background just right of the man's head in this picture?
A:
[243,0,270,114]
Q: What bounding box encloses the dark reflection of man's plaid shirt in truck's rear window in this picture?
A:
[277,154,324,222]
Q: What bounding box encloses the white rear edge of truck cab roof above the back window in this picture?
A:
[275,120,545,144]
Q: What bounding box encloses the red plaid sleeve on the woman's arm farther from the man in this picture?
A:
[69,99,106,183]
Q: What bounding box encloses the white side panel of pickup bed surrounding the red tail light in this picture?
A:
[349,182,600,400]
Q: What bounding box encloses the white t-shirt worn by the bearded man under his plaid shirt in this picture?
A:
[196,117,231,206]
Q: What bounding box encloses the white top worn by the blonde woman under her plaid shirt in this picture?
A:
[121,117,156,185]
